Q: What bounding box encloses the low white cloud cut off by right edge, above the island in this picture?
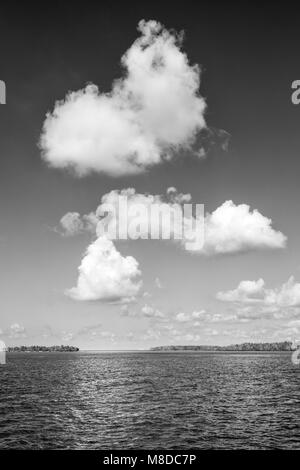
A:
[217,276,300,313]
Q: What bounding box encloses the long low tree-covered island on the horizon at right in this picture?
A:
[150,341,296,351]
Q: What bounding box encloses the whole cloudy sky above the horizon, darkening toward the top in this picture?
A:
[0,1,300,349]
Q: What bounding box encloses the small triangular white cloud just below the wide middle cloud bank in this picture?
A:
[66,237,142,301]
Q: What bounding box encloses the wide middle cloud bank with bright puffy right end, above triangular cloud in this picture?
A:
[58,187,287,256]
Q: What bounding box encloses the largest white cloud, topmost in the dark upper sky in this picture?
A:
[40,20,205,176]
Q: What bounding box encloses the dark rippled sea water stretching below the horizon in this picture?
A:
[0,352,300,450]
